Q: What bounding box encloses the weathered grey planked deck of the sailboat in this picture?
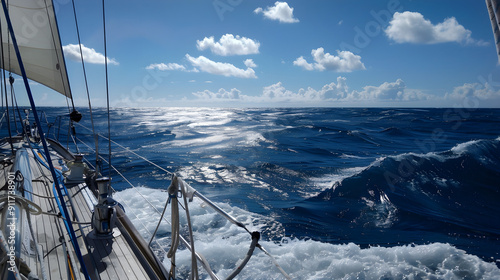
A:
[0,142,167,280]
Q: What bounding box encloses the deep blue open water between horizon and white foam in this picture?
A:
[2,108,500,279]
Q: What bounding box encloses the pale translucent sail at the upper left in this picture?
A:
[0,0,71,98]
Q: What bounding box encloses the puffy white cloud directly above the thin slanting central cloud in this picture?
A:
[196,34,260,56]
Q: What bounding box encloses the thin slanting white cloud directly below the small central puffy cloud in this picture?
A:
[186,54,257,78]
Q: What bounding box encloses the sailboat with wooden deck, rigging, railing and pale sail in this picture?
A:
[0,0,289,280]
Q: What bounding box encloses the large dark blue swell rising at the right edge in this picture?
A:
[312,139,500,235]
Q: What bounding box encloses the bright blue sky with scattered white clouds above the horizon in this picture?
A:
[11,0,500,108]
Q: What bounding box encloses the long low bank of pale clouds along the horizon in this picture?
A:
[188,76,500,107]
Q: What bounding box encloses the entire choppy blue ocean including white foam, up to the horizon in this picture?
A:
[2,108,500,279]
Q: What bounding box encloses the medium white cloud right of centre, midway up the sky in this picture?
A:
[293,48,366,72]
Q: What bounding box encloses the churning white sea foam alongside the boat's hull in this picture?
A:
[115,187,500,280]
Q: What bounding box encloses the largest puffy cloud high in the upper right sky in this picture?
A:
[385,11,486,45]
